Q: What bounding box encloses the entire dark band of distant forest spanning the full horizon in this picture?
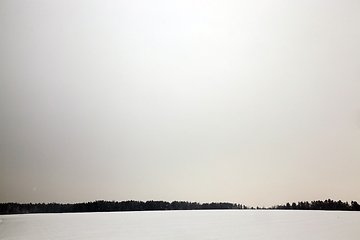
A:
[0,199,360,214]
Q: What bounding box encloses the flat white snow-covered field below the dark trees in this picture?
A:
[0,210,360,240]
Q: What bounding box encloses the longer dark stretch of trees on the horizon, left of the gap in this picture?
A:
[0,200,248,214]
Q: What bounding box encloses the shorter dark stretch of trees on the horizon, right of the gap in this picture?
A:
[271,199,360,211]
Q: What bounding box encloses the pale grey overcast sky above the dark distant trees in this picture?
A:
[0,1,360,206]
